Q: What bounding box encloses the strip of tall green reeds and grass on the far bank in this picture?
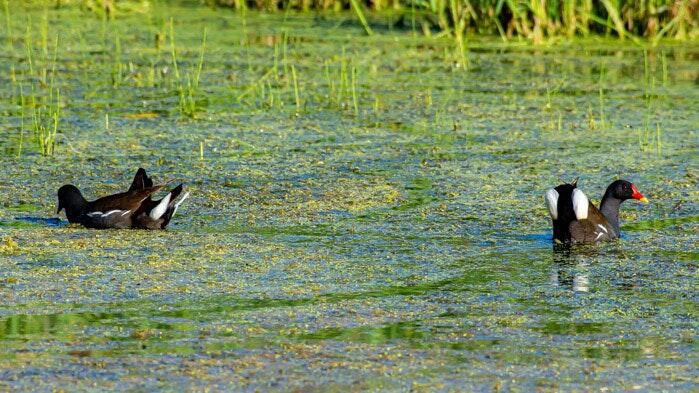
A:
[25,0,699,43]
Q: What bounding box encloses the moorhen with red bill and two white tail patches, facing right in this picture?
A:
[545,179,648,243]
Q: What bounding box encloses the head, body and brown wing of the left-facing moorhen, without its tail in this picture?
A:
[56,184,165,229]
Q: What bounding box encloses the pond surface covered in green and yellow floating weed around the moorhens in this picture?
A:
[0,6,699,391]
